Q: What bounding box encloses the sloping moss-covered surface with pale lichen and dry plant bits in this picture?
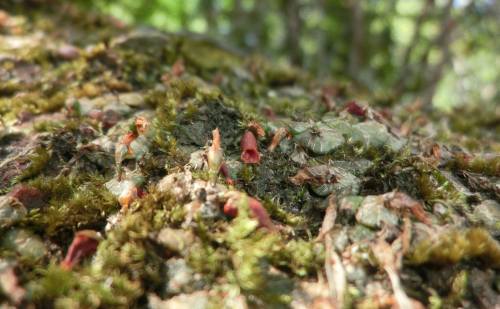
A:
[0,1,500,308]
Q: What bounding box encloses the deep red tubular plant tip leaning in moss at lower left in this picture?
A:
[61,230,99,270]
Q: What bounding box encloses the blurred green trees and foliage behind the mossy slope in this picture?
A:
[82,0,500,108]
